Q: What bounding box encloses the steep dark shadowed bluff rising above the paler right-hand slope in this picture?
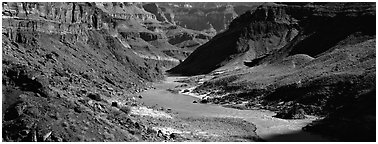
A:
[169,4,375,75]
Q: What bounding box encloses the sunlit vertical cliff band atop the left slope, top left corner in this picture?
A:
[3,3,102,43]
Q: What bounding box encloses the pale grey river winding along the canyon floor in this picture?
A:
[140,77,330,141]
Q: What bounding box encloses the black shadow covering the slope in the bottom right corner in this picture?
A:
[304,90,376,142]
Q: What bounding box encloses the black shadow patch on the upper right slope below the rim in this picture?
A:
[289,14,375,57]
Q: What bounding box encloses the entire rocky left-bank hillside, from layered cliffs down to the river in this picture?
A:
[2,2,211,141]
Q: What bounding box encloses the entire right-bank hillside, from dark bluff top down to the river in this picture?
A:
[168,3,376,141]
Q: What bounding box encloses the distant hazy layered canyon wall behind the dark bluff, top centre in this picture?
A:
[148,2,261,33]
